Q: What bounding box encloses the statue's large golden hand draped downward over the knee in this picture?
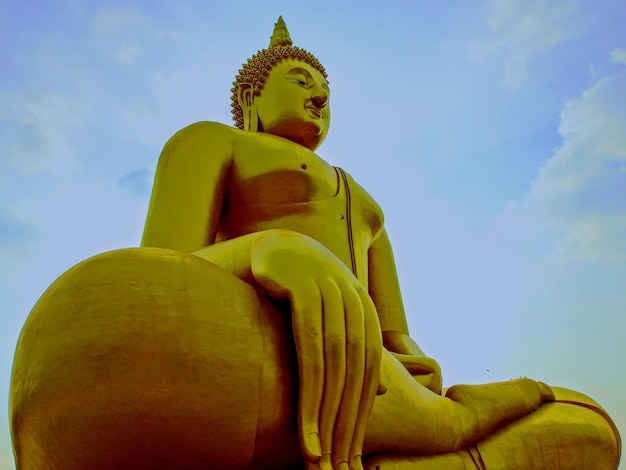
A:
[251,230,382,469]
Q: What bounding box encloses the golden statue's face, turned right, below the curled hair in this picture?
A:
[254,59,330,150]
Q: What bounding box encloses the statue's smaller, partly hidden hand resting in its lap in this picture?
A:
[383,331,443,395]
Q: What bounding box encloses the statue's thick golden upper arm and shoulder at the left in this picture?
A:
[141,122,233,252]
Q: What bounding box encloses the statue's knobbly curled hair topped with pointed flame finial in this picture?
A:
[230,16,328,129]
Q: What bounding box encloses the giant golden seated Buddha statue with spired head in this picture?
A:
[10,18,620,470]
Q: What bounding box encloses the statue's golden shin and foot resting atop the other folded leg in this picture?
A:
[365,351,552,455]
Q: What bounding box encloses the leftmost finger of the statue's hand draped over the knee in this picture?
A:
[290,281,324,462]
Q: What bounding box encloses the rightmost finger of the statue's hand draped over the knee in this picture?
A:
[350,291,383,470]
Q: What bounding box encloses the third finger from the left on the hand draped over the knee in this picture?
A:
[332,283,365,468]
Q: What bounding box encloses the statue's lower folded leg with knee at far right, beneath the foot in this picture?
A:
[365,388,621,470]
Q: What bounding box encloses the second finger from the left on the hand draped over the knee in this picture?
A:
[318,279,346,468]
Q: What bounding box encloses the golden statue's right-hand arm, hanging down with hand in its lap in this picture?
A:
[368,230,441,392]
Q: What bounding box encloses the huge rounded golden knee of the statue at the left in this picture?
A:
[10,249,299,470]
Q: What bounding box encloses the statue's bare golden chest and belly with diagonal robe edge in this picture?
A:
[217,126,383,283]
